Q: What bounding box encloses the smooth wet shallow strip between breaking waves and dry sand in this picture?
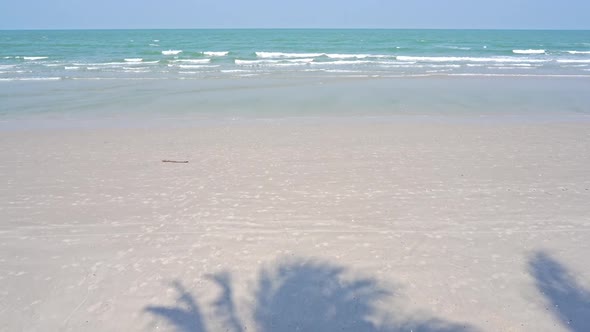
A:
[0,77,590,131]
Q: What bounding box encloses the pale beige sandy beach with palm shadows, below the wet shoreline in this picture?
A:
[0,121,590,332]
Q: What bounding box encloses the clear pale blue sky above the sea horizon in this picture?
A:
[0,0,590,29]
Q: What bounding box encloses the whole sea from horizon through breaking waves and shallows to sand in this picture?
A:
[0,30,590,130]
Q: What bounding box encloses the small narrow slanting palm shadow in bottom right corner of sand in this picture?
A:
[529,252,590,332]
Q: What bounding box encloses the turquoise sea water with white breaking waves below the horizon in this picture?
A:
[0,30,590,81]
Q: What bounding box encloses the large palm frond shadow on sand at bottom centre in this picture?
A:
[144,259,475,332]
